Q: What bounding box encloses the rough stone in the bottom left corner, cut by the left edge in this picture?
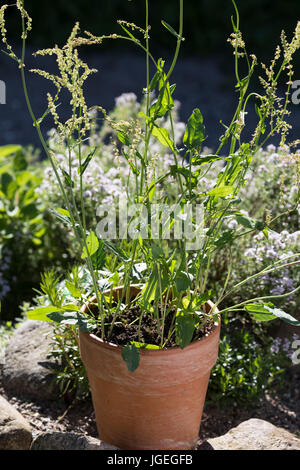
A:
[0,396,32,450]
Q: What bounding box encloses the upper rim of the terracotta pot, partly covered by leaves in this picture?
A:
[79,284,221,356]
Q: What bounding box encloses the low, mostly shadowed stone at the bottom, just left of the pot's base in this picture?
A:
[30,432,117,450]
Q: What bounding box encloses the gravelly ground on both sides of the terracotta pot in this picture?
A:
[0,368,300,444]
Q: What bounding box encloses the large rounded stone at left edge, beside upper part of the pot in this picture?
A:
[2,320,59,400]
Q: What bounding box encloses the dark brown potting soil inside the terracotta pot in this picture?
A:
[93,306,215,348]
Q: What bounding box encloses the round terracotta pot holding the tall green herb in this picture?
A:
[79,288,220,450]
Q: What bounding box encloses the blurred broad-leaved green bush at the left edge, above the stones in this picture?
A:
[0,145,78,320]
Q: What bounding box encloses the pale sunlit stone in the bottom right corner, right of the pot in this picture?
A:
[199,418,300,450]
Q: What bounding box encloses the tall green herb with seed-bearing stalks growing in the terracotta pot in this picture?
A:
[0,0,300,371]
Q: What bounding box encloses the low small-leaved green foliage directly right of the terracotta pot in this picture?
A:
[207,321,291,406]
